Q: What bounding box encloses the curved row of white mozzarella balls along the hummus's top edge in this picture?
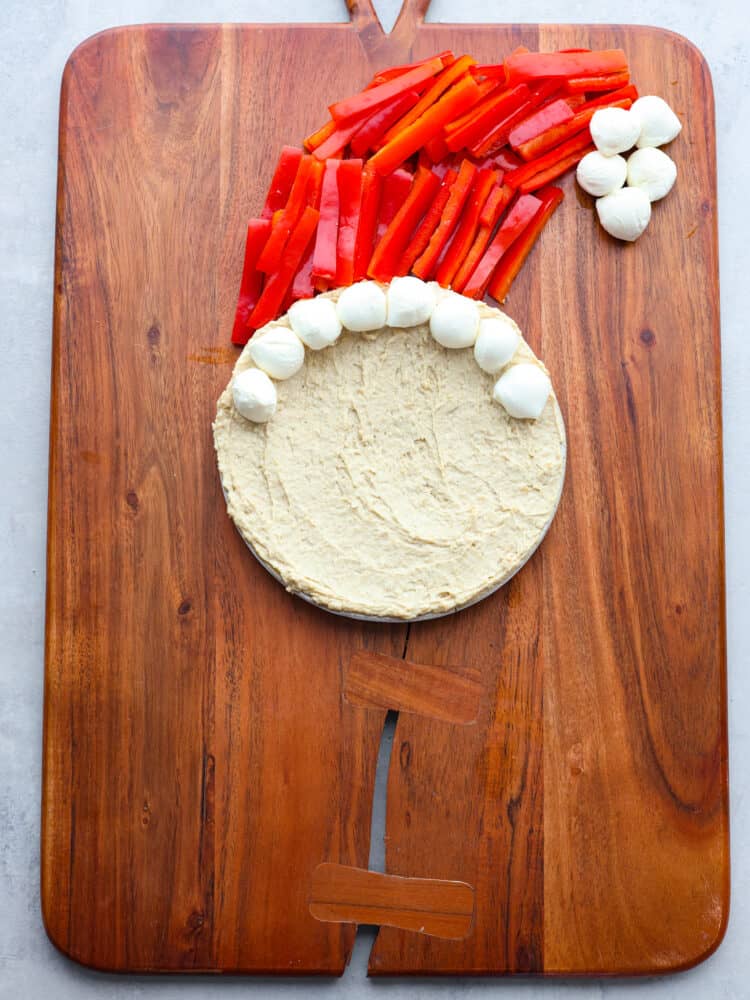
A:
[232,276,551,423]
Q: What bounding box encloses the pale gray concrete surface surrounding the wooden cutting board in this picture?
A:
[0,0,750,1000]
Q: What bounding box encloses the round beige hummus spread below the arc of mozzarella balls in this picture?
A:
[214,292,565,620]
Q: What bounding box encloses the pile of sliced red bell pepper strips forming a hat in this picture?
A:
[232,49,638,344]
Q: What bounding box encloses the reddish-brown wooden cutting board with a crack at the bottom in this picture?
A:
[42,0,729,975]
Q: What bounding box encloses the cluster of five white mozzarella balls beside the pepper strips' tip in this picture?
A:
[576,96,682,242]
